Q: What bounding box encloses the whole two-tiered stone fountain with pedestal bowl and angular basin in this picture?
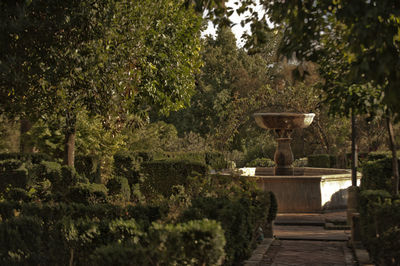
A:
[241,113,361,212]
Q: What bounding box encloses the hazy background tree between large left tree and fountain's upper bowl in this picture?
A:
[161,27,269,150]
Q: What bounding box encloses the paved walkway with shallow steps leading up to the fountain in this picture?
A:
[245,212,356,266]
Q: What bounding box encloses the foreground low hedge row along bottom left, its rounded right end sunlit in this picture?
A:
[0,203,225,265]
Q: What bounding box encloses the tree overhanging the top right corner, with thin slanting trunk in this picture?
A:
[263,0,400,193]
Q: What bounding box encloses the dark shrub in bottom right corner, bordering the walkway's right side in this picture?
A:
[359,190,400,265]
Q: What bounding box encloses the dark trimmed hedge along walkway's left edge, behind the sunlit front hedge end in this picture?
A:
[180,191,277,265]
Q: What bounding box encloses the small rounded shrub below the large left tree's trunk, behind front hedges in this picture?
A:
[66,183,107,204]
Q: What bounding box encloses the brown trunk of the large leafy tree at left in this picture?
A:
[63,112,76,167]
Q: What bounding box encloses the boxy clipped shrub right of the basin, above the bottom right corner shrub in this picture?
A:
[361,157,392,191]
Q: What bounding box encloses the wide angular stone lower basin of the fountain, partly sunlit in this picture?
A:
[240,167,361,213]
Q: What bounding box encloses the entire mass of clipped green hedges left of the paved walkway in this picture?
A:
[0,152,277,265]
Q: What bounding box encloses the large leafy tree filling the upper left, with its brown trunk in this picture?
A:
[0,0,201,166]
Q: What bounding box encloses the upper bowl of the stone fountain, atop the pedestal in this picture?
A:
[253,113,315,129]
